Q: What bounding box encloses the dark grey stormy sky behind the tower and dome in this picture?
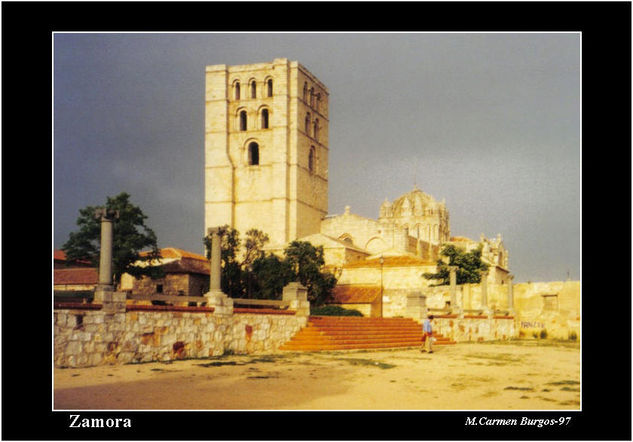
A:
[53,33,581,282]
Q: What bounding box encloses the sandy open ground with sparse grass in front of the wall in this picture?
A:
[54,341,581,410]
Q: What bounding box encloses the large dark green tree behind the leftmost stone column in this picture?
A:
[61,192,163,283]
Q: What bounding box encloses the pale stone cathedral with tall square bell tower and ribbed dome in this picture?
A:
[204,58,509,315]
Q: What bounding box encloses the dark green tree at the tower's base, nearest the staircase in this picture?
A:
[284,241,337,306]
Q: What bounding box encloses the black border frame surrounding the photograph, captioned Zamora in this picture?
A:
[2,2,631,440]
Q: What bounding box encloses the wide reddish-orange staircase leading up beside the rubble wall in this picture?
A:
[280,316,455,351]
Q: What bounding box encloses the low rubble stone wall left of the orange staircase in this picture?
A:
[54,309,307,367]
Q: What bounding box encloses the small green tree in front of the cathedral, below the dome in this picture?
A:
[423,244,488,286]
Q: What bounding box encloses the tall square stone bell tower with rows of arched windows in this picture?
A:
[205,58,329,248]
